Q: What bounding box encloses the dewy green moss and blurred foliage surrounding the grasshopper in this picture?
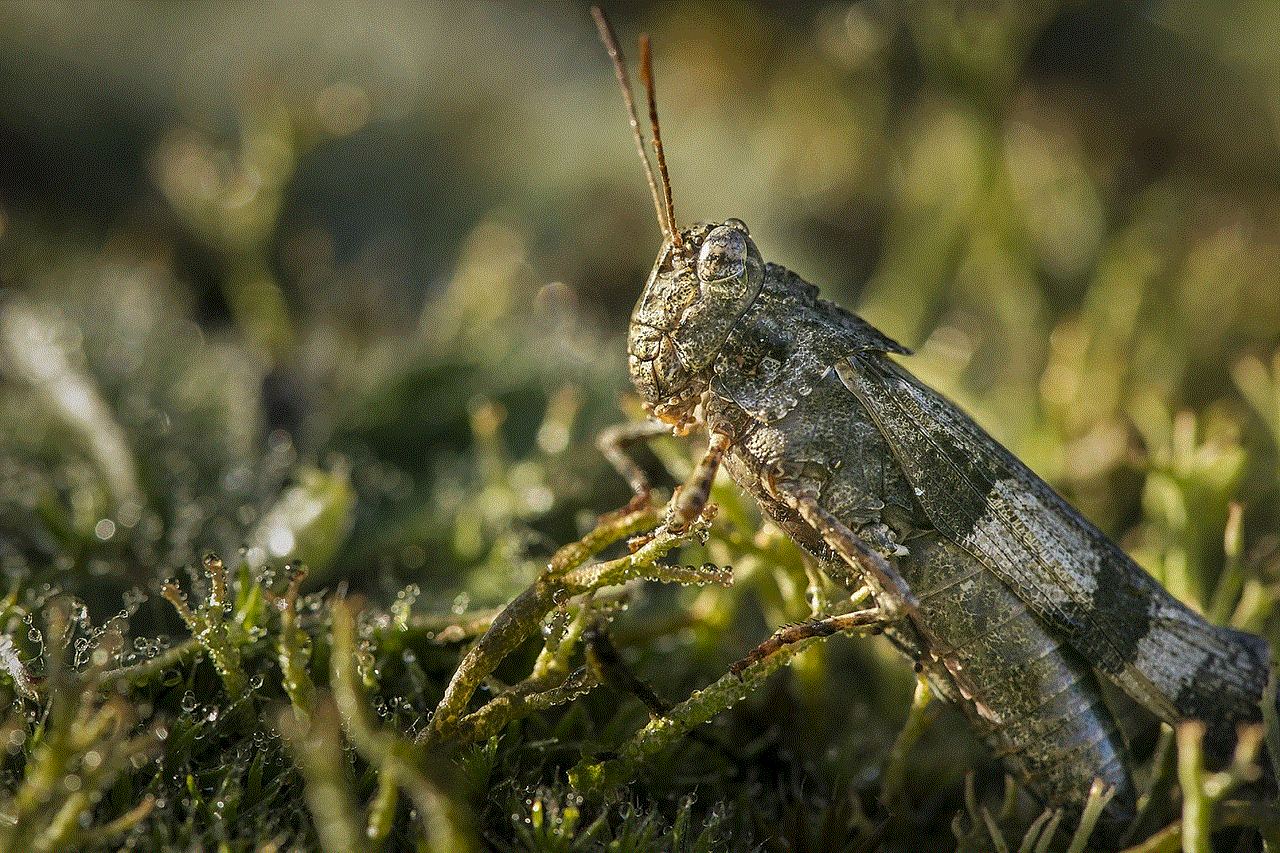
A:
[0,3,1280,852]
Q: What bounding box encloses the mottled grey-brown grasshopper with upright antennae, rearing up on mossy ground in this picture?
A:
[594,10,1271,833]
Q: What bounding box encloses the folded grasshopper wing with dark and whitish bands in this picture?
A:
[835,351,1270,748]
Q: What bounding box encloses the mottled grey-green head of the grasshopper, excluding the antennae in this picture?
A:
[627,219,764,423]
